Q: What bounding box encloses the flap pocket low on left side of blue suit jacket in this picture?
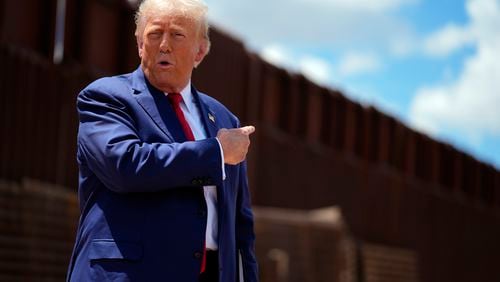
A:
[89,239,143,261]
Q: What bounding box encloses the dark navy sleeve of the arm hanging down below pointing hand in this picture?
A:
[236,161,259,282]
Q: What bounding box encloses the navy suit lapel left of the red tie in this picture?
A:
[132,67,186,142]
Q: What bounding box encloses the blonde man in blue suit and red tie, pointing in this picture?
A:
[67,0,258,282]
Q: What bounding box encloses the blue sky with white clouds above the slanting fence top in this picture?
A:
[205,0,500,169]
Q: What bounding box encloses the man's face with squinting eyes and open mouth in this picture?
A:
[138,14,206,93]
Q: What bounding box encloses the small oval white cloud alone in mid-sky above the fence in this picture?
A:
[338,52,382,76]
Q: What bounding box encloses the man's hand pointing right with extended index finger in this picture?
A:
[217,126,255,165]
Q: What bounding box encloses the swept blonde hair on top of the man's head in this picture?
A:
[135,0,210,48]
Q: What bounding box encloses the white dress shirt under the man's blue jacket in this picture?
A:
[165,82,226,250]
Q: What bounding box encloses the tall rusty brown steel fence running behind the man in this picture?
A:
[0,0,500,281]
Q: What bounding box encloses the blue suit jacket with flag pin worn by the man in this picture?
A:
[67,67,258,282]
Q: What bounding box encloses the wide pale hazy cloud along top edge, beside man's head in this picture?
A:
[206,0,419,50]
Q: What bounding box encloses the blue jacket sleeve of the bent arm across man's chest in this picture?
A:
[77,83,222,193]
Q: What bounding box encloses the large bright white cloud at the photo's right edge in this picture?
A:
[410,0,500,143]
